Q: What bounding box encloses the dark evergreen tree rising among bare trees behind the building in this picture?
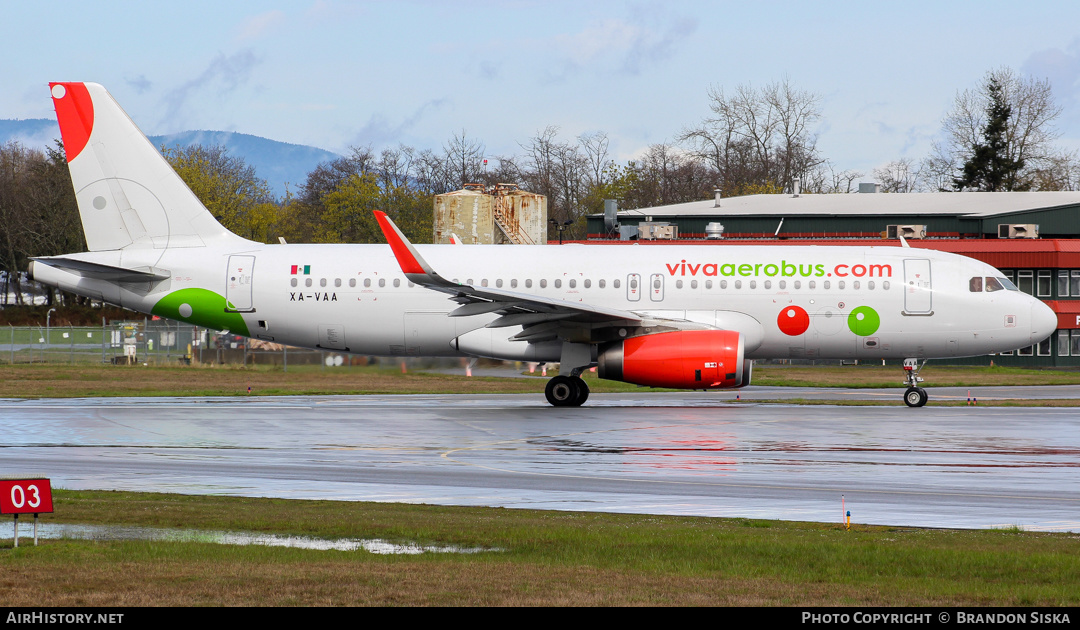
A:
[953,77,1030,192]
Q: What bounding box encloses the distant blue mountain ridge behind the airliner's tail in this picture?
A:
[0,118,341,198]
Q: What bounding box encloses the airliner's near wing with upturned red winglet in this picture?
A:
[375,211,644,341]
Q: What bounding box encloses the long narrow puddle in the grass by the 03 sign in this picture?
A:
[0,523,501,555]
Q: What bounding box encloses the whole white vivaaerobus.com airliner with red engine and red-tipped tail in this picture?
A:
[30,83,1056,406]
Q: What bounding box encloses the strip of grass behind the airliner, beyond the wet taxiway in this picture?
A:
[0,364,1080,406]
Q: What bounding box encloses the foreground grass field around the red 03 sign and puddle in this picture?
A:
[0,491,1080,606]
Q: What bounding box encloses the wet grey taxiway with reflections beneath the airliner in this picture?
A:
[0,388,1080,532]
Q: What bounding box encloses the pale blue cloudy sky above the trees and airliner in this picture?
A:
[8,0,1080,179]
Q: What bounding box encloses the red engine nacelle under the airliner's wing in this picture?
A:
[596,331,752,389]
